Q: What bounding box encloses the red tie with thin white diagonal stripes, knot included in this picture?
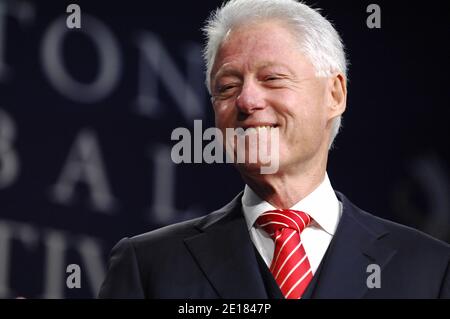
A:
[256,209,313,299]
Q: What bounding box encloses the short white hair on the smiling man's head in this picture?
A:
[203,0,347,148]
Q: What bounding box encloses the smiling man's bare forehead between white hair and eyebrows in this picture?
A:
[211,20,312,77]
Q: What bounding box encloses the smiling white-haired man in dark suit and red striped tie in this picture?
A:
[99,0,450,299]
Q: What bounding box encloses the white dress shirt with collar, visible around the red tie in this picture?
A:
[242,174,342,274]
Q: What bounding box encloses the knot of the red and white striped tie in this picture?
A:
[256,209,311,237]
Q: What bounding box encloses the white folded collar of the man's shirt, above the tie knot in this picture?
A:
[242,174,341,235]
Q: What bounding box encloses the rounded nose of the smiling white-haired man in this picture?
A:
[236,81,266,114]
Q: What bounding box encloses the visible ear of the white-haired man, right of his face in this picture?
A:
[328,73,347,119]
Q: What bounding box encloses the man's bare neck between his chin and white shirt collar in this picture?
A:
[241,154,327,209]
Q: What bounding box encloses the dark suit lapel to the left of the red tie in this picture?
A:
[185,194,267,298]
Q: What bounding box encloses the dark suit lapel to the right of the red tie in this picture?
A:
[313,193,396,298]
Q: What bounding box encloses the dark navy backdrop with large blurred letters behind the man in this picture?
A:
[0,0,450,298]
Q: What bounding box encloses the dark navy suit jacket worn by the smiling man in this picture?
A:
[99,193,450,299]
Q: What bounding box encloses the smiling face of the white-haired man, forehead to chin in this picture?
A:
[211,21,343,176]
